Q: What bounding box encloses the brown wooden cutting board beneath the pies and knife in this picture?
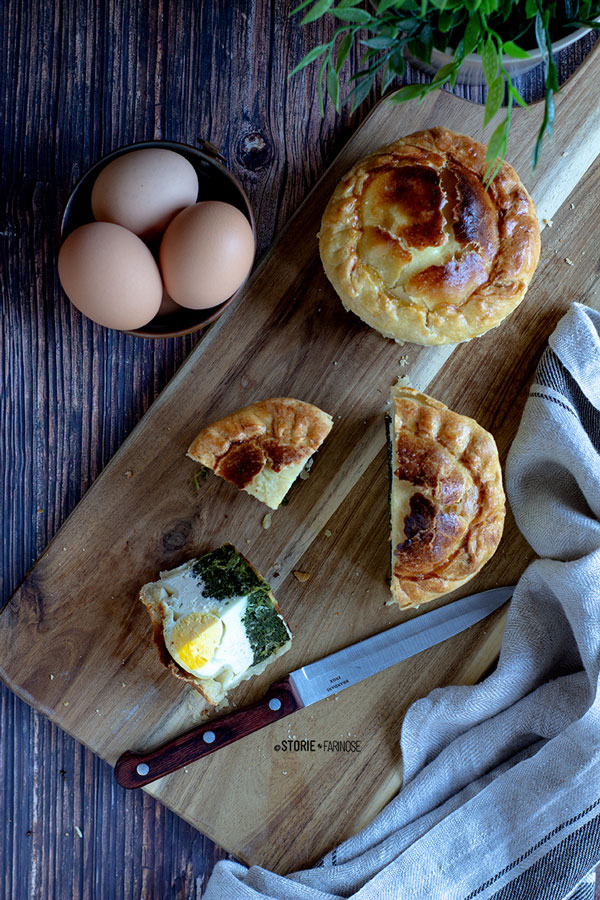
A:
[0,45,600,871]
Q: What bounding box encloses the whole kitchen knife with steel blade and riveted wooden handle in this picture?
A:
[115,586,514,788]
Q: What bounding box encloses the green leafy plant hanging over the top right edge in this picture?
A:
[290,0,600,173]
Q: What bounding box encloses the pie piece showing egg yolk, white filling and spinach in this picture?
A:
[140,544,292,705]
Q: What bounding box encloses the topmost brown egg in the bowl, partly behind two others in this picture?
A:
[92,147,198,240]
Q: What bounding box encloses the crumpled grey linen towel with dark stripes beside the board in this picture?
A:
[204,304,600,900]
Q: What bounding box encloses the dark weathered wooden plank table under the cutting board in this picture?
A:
[0,0,592,900]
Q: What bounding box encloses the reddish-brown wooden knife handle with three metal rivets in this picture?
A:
[115,678,302,788]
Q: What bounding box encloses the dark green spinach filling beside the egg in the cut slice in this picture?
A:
[192,544,289,666]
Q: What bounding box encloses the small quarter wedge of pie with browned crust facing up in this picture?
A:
[188,397,333,509]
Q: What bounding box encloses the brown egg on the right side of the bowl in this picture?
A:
[160,200,255,309]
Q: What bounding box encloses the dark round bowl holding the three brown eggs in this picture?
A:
[60,140,256,338]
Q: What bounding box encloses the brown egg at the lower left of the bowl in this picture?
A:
[58,222,163,331]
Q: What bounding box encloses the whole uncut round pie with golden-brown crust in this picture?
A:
[319,128,540,344]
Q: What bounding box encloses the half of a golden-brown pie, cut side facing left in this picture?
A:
[389,385,505,606]
